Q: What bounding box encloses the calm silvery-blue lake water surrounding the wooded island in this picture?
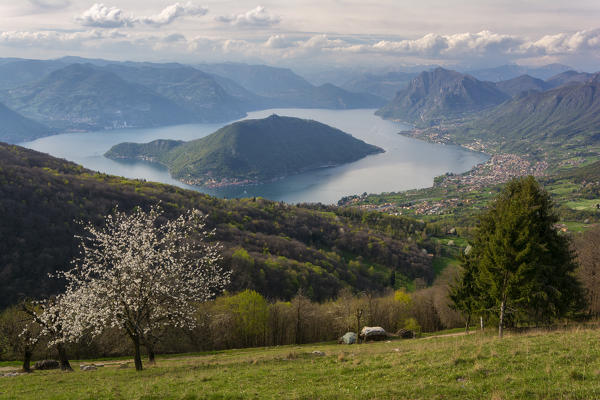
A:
[21,108,488,204]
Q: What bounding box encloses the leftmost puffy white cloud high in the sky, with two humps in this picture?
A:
[76,2,208,28]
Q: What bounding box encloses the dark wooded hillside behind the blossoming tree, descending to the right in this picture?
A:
[0,144,434,308]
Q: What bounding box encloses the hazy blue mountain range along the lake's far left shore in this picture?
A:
[0,57,385,142]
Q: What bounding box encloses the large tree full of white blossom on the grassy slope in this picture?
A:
[56,207,230,371]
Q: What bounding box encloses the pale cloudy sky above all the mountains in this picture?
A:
[0,0,600,71]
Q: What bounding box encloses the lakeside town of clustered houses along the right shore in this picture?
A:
[339,152,548,215]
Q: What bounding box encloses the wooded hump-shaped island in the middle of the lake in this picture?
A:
[105,115,384,187]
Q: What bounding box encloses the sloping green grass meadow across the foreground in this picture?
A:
[0,329,600,399]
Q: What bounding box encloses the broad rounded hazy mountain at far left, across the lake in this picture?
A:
[2,64,194,130]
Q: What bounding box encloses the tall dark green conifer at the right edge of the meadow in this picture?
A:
[453,176,583,337]
